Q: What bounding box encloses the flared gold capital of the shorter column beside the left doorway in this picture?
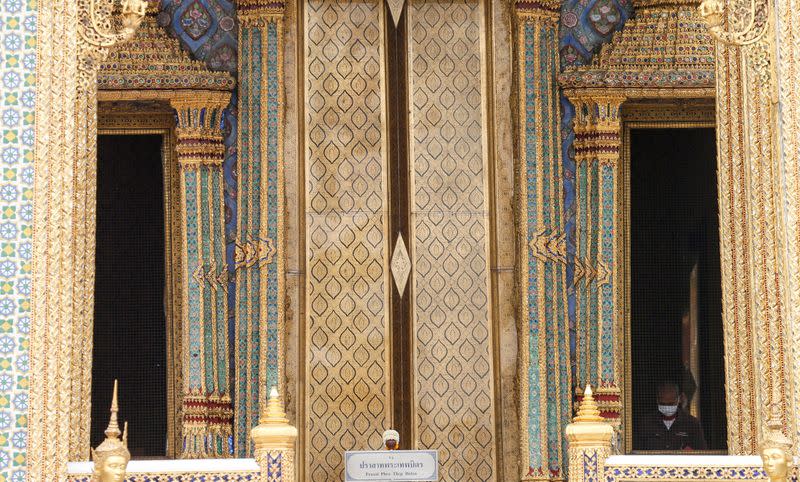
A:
[170,91,231,168]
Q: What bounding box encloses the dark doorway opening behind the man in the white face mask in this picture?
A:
[630,128,727,450]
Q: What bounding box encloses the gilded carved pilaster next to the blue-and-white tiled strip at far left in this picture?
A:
[32,1,82,470]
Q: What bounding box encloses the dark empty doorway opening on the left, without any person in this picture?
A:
[91,135,167,457]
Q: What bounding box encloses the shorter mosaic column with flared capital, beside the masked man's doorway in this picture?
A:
[567,92,625,428]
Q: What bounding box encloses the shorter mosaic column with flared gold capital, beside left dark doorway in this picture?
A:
[171,92,233,458]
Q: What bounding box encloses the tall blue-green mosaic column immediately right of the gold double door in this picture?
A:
[516,1,572,480]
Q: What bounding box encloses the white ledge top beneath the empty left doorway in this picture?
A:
[67,459,259,475]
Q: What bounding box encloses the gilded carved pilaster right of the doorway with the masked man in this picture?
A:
[699,1,786,454]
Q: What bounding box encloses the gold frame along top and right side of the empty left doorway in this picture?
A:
[97,103,184,458]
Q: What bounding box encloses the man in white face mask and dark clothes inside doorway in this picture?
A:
[636,382,708,451]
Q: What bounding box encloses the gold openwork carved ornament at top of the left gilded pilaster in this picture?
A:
[78,0,148,92]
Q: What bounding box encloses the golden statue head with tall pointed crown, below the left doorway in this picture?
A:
[92,380,131,482]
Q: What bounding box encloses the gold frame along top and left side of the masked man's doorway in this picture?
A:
[617,99,726,454]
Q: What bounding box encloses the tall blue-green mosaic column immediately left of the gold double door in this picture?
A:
[234,0,284,457]
